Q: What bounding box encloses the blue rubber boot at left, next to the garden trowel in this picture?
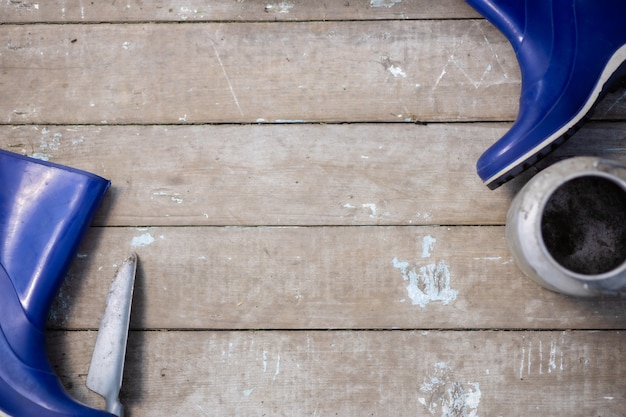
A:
[0,150,112,417]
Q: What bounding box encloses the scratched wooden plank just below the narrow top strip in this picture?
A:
[0,20,520,124]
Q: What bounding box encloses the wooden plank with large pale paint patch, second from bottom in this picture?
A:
[51,226,626,330]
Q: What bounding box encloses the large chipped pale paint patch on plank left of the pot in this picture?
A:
[392,258,459,307]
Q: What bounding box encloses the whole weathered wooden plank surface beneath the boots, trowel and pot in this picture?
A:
[0,0,626,417]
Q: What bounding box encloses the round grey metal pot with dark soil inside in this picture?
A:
[506,157,626,296]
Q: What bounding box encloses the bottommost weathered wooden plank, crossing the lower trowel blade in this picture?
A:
[49,331,626,417]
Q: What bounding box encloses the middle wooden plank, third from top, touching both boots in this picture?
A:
[0,123,626,226]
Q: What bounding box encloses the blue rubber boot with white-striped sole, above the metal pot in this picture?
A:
[467,0,626,189]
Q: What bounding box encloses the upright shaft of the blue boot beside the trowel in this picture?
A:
[0,150,110,330]
